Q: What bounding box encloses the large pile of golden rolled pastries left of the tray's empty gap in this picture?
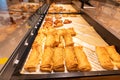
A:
[24,27,91,72]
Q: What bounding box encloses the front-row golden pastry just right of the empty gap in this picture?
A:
[96,46,114,70]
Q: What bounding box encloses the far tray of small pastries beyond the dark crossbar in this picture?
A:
[48,3,79,13]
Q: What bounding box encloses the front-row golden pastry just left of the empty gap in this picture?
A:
[74,46,91,71]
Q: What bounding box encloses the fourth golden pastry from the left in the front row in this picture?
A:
[65,47,78,71]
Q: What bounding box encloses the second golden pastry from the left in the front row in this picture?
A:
[40,47,53,72]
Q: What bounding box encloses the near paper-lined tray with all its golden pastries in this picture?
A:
[20,14,120,77]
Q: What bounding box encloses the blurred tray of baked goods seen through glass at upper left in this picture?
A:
[9,2,43,13]
